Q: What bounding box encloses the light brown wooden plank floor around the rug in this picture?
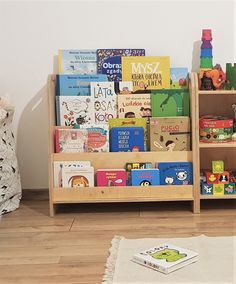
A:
[0,190,236,284]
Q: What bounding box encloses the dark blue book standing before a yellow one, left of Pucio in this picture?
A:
[110,127,144,152]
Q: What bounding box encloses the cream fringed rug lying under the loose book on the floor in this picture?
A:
[103,235,236,284]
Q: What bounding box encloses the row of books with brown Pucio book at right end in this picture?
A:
[55,116,190,153]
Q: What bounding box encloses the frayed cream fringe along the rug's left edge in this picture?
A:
[102,236,124,284]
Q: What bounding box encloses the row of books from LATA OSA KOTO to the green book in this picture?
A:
[56,82,189,126]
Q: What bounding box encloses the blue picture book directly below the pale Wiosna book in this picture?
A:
[56,74,107,96]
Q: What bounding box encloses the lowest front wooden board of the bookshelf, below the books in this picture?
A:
[53,185,194,204]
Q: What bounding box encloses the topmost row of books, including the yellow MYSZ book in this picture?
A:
[58,48,186,91]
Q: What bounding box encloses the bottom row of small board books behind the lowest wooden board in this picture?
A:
[54,161,193,188]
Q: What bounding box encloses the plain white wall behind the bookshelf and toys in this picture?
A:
[0,0,234,188]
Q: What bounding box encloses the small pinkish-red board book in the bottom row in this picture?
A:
[96,169,126,186]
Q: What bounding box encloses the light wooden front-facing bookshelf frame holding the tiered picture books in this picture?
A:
[48,75,197,216]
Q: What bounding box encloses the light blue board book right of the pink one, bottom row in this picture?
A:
[131,169,160,186]
